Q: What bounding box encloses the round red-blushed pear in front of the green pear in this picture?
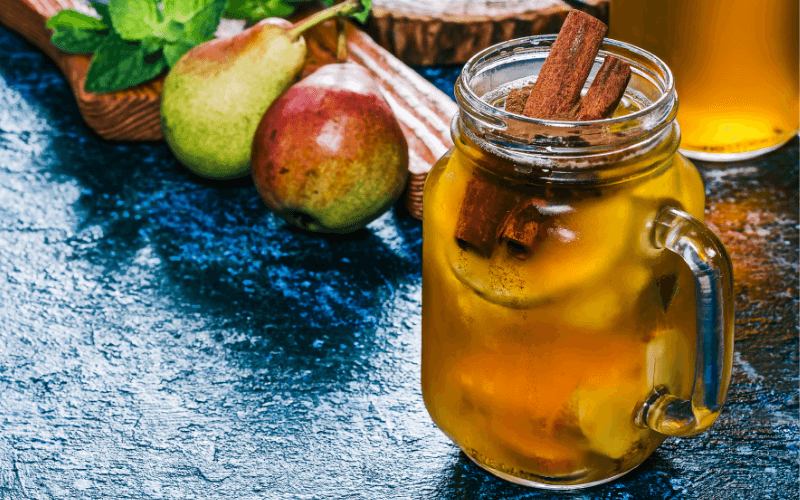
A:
[250,63,408,233]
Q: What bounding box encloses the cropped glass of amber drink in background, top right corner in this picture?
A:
[608,0,800,155]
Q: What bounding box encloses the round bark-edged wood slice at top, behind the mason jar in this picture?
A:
[367,0,610,65]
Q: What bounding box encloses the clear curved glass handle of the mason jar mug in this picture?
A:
[635,207,733,436]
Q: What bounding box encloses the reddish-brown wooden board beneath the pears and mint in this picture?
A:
[0,0,458,219]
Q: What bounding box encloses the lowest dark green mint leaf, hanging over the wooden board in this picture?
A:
[84,36,167,93]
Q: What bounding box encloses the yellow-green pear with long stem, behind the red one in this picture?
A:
[161,1,360,179]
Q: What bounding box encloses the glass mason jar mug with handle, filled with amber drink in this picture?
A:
[422,36,733,489]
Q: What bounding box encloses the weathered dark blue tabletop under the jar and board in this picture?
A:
[0,27,800,500]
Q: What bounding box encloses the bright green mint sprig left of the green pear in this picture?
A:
[47,0,229,93]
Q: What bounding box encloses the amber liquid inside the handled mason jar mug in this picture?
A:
[422,137,704,486]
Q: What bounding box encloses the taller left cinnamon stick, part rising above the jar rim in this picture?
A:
[523,10,608,119]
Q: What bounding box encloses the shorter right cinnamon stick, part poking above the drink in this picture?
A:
[575,56,631,121]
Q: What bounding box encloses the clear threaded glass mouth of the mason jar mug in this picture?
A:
[453,35,679,182]
